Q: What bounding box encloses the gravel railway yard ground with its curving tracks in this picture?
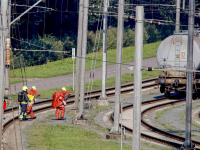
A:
[3,79,200,150]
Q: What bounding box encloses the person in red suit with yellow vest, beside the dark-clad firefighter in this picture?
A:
[27,86,40,119]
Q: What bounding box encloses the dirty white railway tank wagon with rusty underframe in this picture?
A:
[157,29,200,97]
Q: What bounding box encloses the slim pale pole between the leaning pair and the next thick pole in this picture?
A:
[100,0,108,100]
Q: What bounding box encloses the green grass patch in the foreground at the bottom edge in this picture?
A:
[27,123,131,150]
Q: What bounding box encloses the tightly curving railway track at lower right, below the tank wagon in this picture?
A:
[110,98,200,149]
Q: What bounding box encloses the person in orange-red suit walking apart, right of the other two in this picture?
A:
[56,87,72,120]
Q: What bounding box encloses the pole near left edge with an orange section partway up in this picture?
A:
[3,0,11,97]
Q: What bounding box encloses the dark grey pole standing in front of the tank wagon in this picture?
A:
[184,0,195,148]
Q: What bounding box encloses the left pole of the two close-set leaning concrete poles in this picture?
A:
[74,0,83,109]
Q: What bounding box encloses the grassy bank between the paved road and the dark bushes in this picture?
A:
[10,42,160,78]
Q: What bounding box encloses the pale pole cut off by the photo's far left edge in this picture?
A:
[0,0,8,149]
